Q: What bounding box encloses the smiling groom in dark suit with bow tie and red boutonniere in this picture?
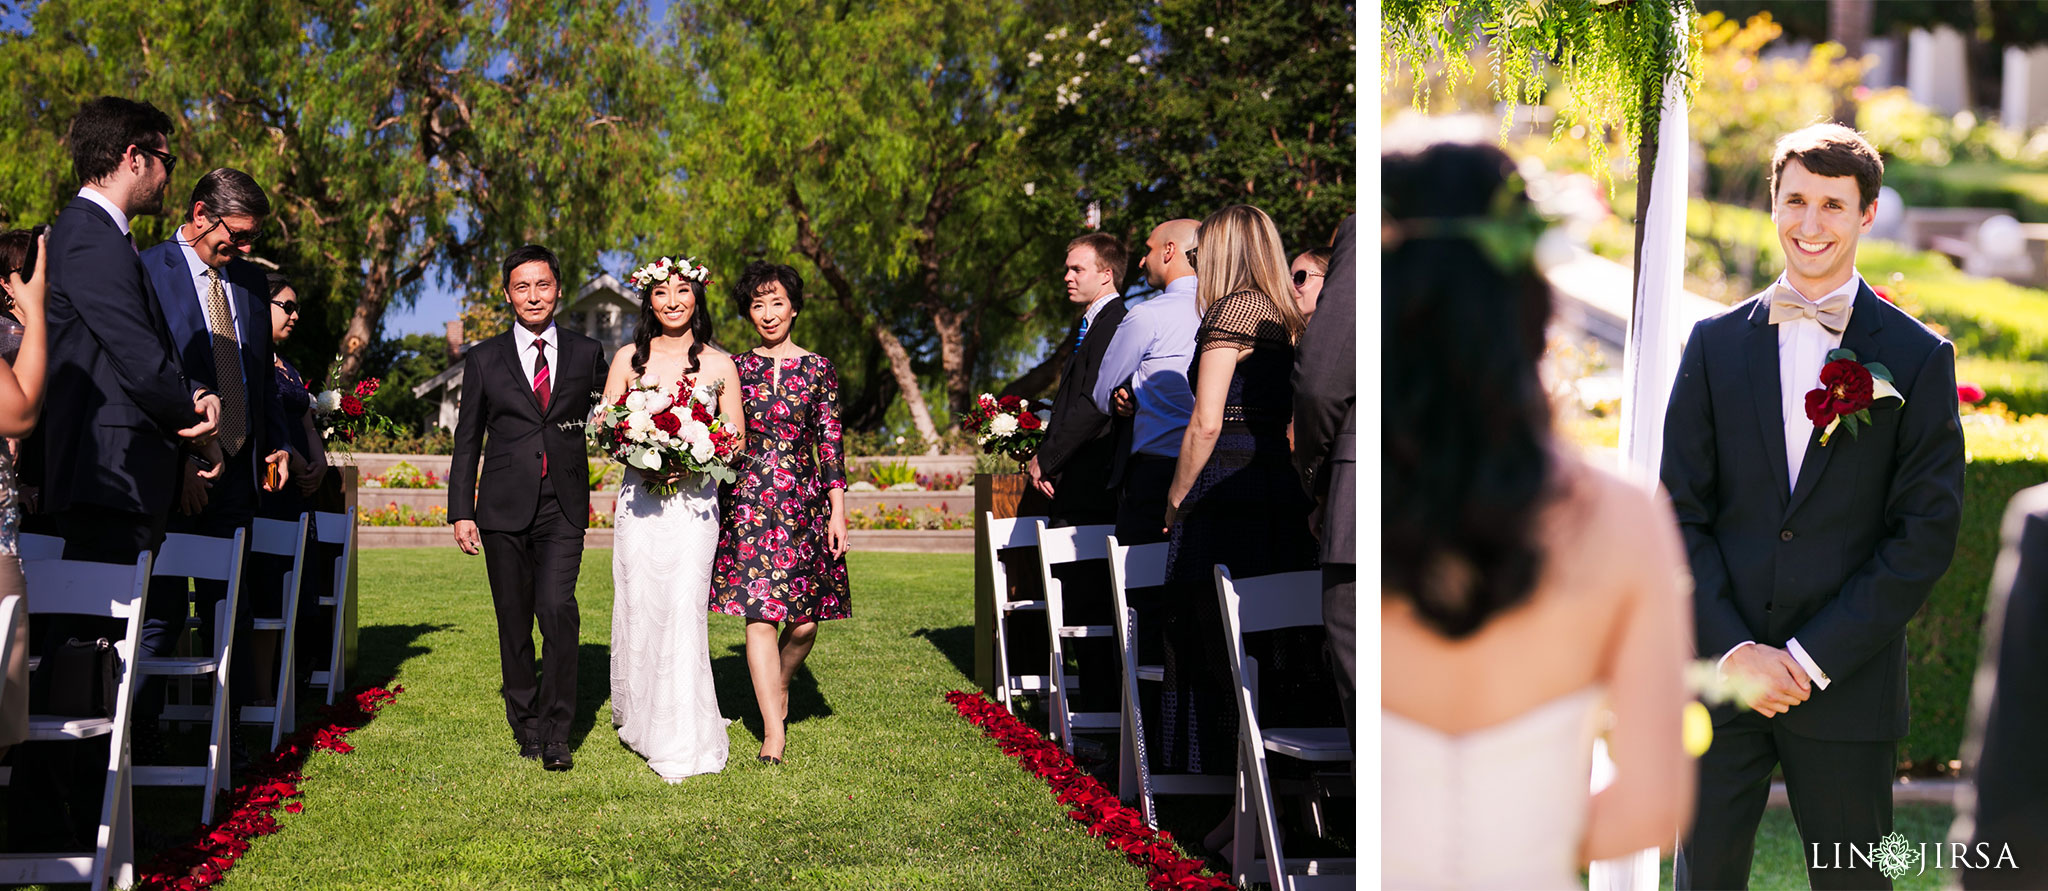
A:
[1661,125,1962,889]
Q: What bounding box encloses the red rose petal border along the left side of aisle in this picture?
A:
[135,684,406,891]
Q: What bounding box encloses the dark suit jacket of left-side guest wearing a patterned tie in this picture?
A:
[141,242,285,475]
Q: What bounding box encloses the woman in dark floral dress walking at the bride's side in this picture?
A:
[711,262,852,764]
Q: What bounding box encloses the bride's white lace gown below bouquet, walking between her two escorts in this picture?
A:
[612,473,729,782]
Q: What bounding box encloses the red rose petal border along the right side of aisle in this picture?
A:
[946,690,1235,891]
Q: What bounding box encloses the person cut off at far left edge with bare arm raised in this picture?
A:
[0,231,49,754]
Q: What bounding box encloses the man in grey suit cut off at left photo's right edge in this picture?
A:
[1294,215,1358,735]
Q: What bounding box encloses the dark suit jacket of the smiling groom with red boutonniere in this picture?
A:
[1661,285,1962,741]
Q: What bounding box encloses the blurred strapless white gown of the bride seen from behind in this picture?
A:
[1380,686,1606,891]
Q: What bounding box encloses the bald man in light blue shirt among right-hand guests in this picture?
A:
[1092,219,1202,545]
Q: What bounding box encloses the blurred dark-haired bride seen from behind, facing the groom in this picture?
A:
[1392,143,1694,889]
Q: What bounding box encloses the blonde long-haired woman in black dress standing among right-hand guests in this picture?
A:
[1153,205,1310,850]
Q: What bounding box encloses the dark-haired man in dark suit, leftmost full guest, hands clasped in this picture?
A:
[8,96,221,850]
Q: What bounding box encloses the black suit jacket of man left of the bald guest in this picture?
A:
[1038,297,1128,522]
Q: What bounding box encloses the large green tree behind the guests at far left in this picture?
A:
[0,0,668,381]
